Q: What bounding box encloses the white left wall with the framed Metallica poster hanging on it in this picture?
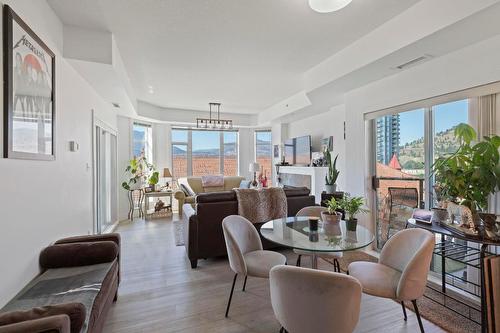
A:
[0,0,116,306]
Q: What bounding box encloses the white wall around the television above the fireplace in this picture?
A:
[287,105,347,190]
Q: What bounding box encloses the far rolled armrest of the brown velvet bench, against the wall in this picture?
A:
[39,241,119,269]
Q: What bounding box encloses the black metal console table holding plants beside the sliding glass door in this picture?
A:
[406,219,500,333]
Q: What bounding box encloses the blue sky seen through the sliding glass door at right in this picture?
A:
[399,100,468,145]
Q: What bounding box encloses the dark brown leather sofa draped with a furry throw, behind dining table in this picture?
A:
[183,187,315,268]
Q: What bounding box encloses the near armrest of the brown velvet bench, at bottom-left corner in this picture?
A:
[0,303,86,333]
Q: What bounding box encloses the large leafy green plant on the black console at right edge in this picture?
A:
[432,123,500,230]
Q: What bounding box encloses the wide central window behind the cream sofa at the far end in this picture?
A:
[172,128,238,179]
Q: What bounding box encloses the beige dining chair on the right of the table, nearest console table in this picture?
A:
[348,229,435,332]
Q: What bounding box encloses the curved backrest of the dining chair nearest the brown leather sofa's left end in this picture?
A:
[222,215,262,275]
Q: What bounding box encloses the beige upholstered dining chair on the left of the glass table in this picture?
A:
[222,215,286,317]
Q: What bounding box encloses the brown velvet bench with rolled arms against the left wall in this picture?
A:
[0,234,120,333]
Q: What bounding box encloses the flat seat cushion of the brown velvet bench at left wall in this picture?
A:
[1,260,117,332]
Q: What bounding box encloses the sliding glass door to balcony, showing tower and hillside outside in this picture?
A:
[373,100,469,248]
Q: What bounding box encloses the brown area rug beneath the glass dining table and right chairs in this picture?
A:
[339,251,481,333]
